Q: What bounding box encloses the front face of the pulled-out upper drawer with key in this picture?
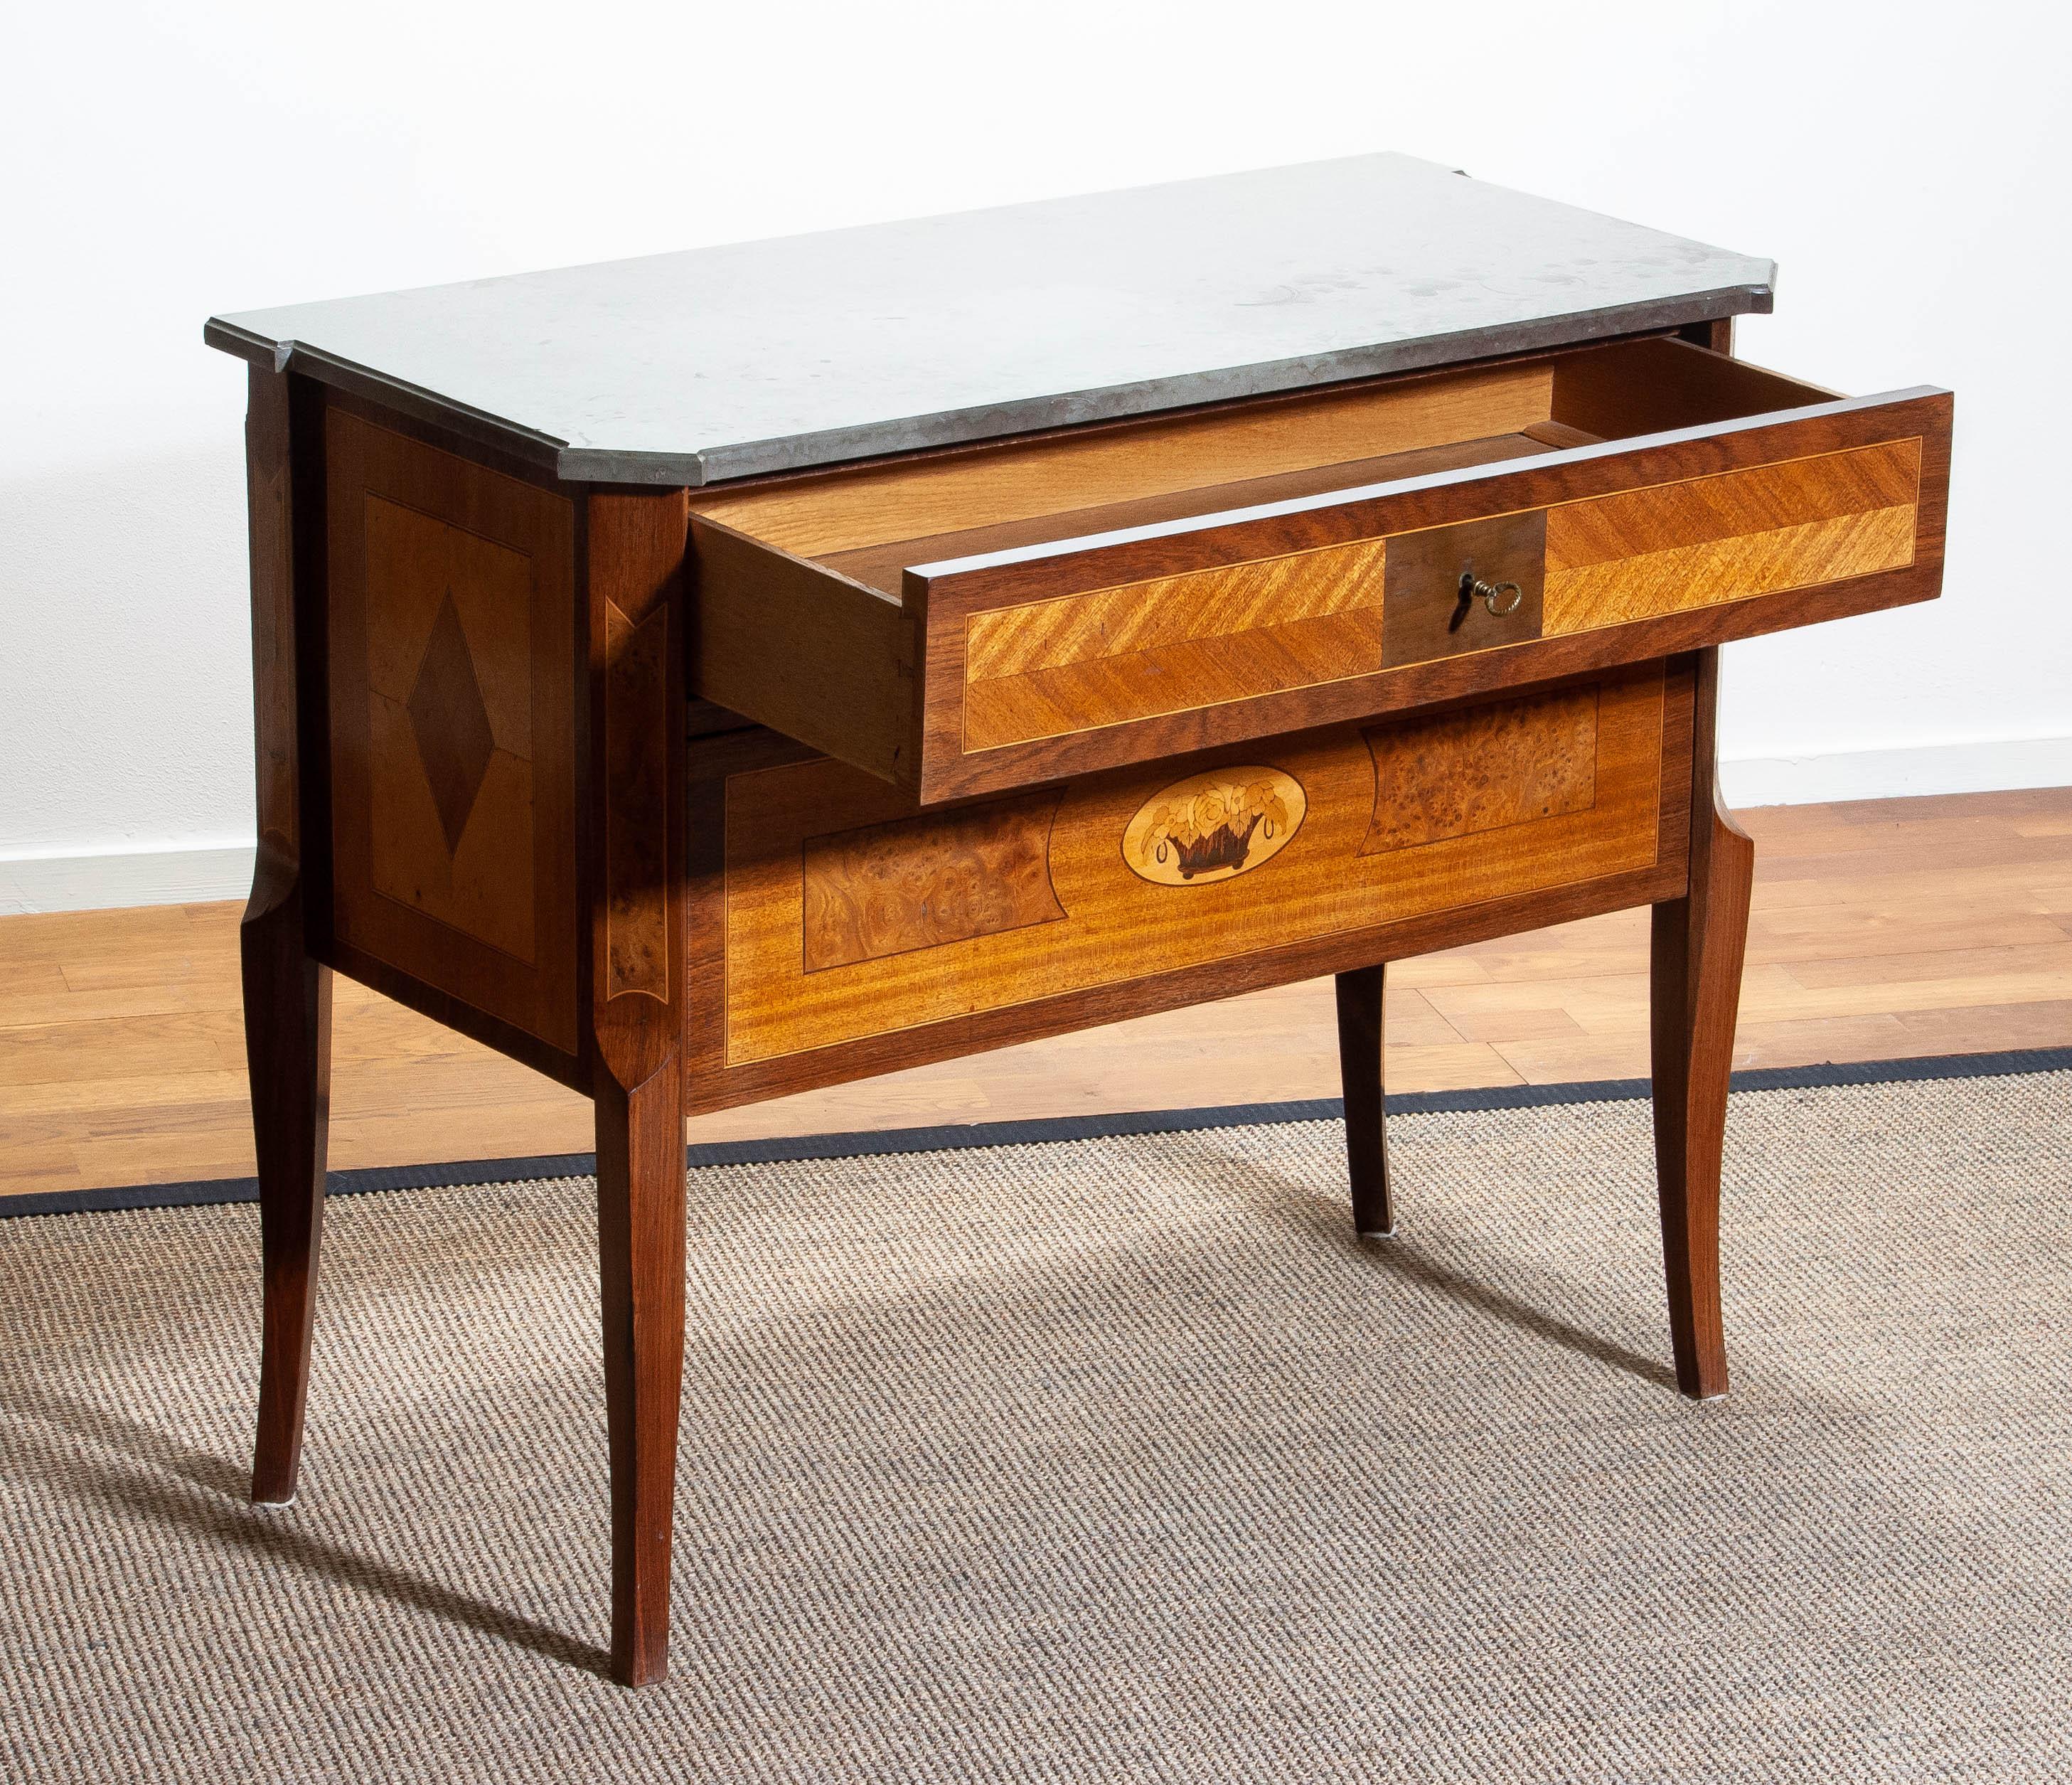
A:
[907,394,1950,800]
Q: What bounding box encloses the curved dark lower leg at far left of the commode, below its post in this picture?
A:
[238,892,331,1505]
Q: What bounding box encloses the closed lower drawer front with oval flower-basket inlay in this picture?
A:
[690,659,1691,1109]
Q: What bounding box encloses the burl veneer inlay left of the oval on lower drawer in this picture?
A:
[804,792,1065,972]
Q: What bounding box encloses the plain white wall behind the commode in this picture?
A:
[0,0,2072,904]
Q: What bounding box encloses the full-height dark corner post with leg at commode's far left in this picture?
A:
[238,367,331,1505]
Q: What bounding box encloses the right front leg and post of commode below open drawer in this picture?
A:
[1650,647,1755,1400]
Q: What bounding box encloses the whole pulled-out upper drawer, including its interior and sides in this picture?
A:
[690,338,1952,804]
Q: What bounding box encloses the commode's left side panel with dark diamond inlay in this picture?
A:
[324,406,576,1053]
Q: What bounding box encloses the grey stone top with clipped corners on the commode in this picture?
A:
[205,156,1775,483]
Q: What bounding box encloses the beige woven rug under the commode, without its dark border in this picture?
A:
[0,1072,2072,1781]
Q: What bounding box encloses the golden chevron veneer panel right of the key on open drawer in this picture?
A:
[1544,439,1921,634]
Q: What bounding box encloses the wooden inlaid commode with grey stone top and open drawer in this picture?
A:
[207,156,1950,1683]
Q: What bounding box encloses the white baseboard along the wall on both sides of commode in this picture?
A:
[0,738,2072,917]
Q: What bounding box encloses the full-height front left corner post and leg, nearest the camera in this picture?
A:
[582,489,690,1685]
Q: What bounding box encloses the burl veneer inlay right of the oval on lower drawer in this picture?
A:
[1360,688,1600,854]
